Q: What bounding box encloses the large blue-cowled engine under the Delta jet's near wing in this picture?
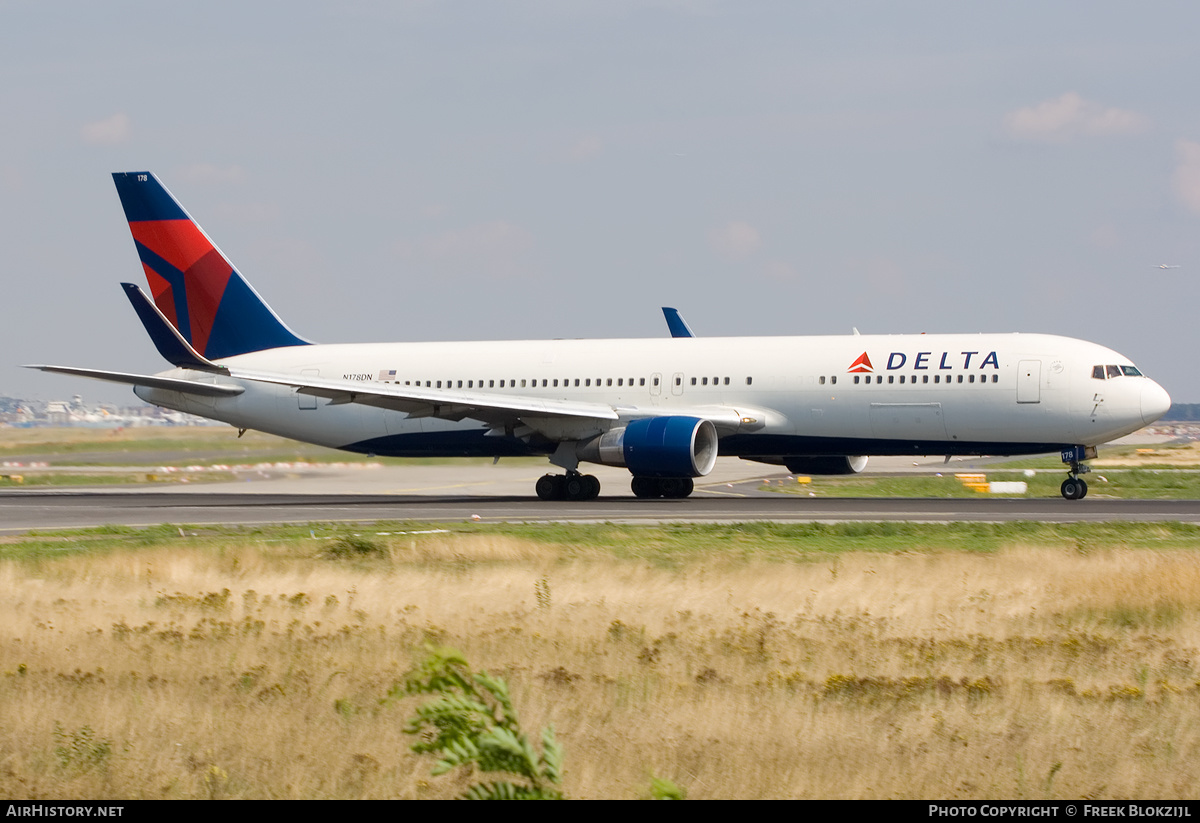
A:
[580,416,716,477]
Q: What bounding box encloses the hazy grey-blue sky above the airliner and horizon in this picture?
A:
[0,0,1200,404]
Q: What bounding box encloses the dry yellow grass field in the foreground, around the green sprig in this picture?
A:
[0,535,1200,798]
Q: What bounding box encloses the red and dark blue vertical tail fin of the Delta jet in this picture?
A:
[113,172,308,360]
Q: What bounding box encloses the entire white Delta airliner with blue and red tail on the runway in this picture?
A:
[29,172,1171,500]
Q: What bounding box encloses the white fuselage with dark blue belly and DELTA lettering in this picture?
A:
[137,334,1170,467]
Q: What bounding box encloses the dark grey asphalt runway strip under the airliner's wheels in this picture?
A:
[0,491,1200,534]
